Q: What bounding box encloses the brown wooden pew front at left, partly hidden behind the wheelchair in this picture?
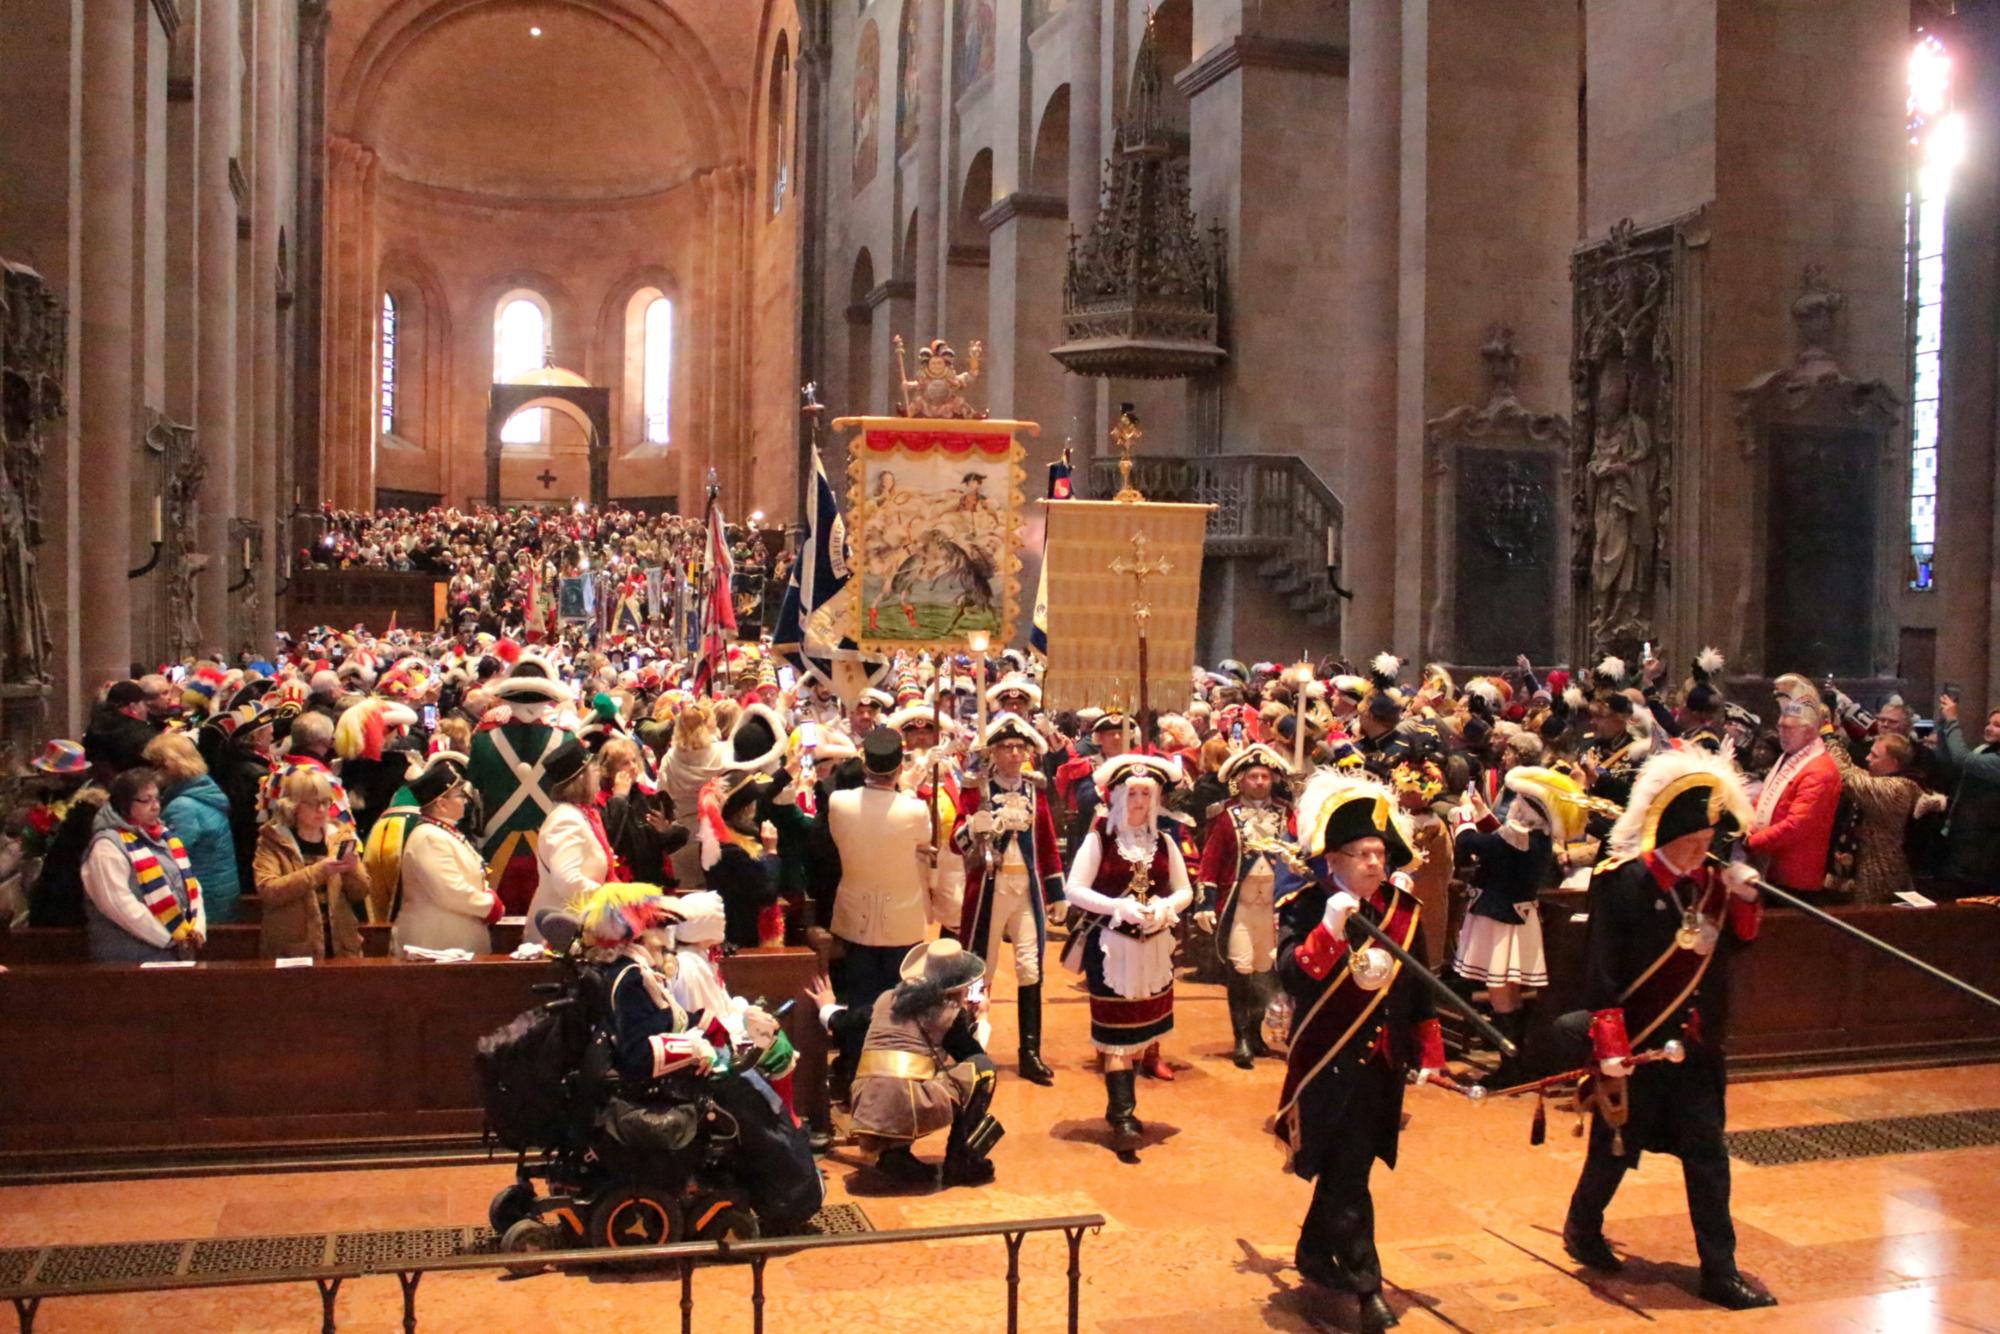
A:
[0,944,826,1168]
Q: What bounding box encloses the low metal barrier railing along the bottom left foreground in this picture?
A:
[0,1214,1104,1334]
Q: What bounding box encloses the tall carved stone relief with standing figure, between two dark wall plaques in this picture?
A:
[1570,218,1678,660]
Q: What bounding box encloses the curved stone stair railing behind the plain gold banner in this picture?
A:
[1090,454,1346,624]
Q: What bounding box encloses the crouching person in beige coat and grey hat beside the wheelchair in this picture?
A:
[834,940,1002,1186]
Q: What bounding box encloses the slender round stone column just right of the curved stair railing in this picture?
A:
[1338,0,1414,662]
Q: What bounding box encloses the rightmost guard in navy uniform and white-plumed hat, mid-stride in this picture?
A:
[1558,746,1776,1310]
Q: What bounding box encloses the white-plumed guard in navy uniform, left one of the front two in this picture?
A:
[1274,770,1444,1334]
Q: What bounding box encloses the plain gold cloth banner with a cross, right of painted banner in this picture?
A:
[1042,500,1214,714]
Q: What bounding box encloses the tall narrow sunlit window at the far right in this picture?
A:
[1906,32,1966,590]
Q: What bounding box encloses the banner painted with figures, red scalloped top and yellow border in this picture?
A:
[834,416,1040,650]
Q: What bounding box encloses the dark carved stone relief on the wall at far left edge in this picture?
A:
[0,260,68,686]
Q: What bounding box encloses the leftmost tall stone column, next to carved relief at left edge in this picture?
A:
[70,0,138,700]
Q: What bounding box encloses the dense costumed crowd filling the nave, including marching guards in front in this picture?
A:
[8,560,2000,1328]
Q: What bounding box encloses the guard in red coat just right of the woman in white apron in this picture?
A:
[1194,742,1296,1070]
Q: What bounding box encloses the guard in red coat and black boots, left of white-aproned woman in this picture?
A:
[952,714,1062,1084]
